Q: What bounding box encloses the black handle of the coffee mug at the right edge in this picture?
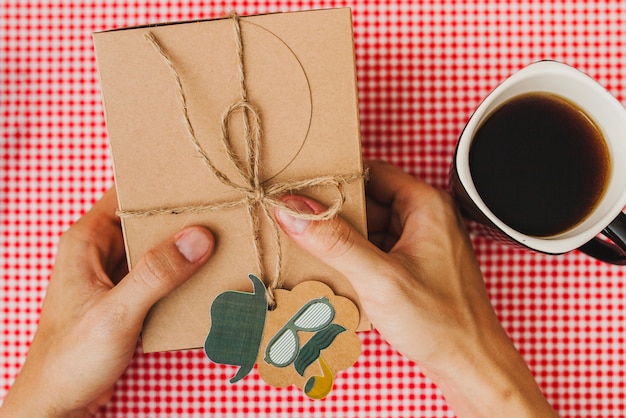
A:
[579,212,626,266]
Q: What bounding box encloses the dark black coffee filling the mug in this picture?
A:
[469,93,611,236]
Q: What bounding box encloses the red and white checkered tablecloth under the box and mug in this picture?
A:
[0,0,626,418]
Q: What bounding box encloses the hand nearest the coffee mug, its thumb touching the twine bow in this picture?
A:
[276,162,555,417]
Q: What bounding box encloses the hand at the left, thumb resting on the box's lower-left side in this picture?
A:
[0,189,214,418]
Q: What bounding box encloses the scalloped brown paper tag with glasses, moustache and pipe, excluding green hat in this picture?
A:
[257,281,361,399]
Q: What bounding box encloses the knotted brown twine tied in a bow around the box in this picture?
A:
[117,13,366,309]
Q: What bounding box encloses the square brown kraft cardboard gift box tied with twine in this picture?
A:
[94,9,370,352]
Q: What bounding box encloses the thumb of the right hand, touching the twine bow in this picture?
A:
[276,195,385,280]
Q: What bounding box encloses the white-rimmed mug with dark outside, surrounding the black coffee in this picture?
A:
[451,61,626,264]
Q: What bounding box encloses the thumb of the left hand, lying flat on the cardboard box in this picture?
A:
[110,226,215,322]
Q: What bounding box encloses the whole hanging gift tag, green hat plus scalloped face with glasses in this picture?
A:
[205,275,361,399]
